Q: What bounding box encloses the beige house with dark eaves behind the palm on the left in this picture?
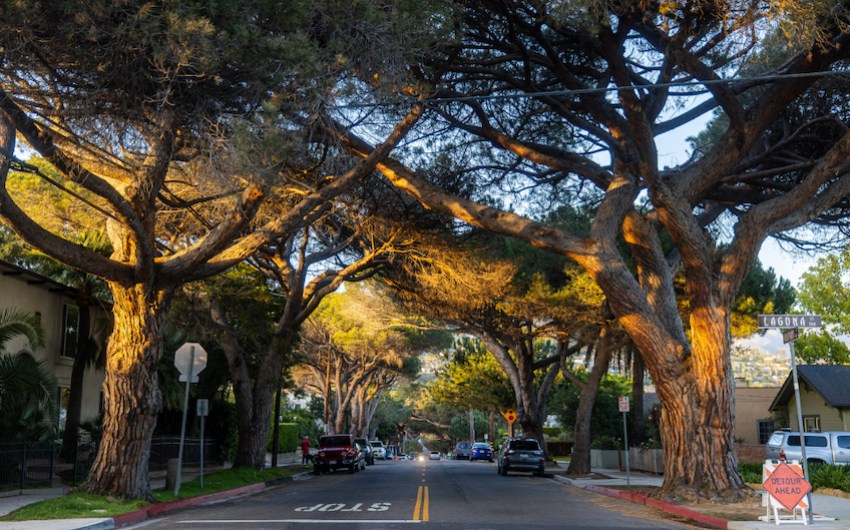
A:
[0,261,109,429]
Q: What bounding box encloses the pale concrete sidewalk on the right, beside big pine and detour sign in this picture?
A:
[555,469,850,530]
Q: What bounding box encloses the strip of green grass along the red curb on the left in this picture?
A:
[0,466,310,521]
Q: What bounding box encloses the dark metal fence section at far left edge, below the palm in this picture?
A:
[0,442,56,491]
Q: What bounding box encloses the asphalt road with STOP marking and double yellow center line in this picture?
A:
[126,460,693,530]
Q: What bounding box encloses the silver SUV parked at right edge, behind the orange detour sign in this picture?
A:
[766,431,850,465]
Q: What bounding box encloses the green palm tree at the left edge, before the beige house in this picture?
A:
[0,309,56,440]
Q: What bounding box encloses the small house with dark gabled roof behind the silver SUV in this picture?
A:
[770,364,850,431]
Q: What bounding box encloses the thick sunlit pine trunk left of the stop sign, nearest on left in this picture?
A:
[82,284,166,500]
